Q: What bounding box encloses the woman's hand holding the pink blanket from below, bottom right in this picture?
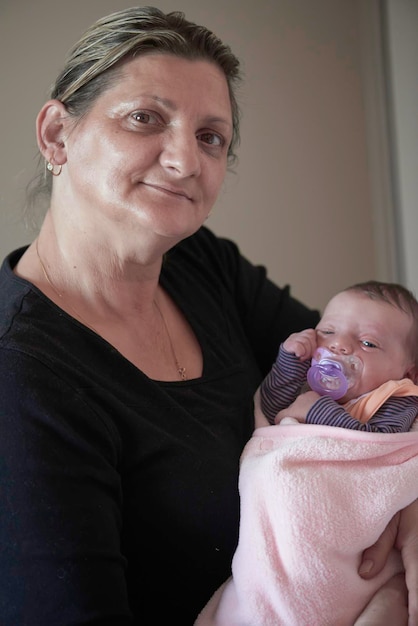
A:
[355,500,418,626]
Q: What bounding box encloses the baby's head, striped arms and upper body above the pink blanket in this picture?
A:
[260,281,418,433]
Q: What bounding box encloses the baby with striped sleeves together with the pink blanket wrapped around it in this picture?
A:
[196,281,418,626]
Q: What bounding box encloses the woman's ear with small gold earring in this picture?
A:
[36,100,68,165]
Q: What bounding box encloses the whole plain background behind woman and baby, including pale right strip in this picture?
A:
[0,0,418,308]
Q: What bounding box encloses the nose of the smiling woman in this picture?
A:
[160,129,201,177]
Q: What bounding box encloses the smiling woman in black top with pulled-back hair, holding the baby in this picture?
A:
[0,8,411,626]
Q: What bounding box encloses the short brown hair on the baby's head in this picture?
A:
[343,280,418,367]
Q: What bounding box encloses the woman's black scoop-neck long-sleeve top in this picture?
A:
[0,228,318,626]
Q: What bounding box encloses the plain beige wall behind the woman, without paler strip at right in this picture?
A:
[0,0,378,307]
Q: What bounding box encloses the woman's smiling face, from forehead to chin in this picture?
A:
[55,54,232,251]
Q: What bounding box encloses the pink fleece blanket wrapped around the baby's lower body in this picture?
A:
[196,424,418,626]
